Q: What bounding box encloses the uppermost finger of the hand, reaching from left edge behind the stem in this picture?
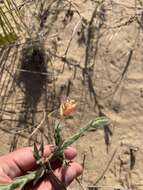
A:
[0,145,53,179]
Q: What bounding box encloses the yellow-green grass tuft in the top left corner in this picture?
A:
[0,0,27,46]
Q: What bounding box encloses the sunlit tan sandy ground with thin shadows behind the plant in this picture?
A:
[0,0,143,190]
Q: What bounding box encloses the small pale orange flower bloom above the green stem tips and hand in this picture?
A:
[60,98,77,116]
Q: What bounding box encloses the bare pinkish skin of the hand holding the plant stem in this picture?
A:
[0,145,82,190]
